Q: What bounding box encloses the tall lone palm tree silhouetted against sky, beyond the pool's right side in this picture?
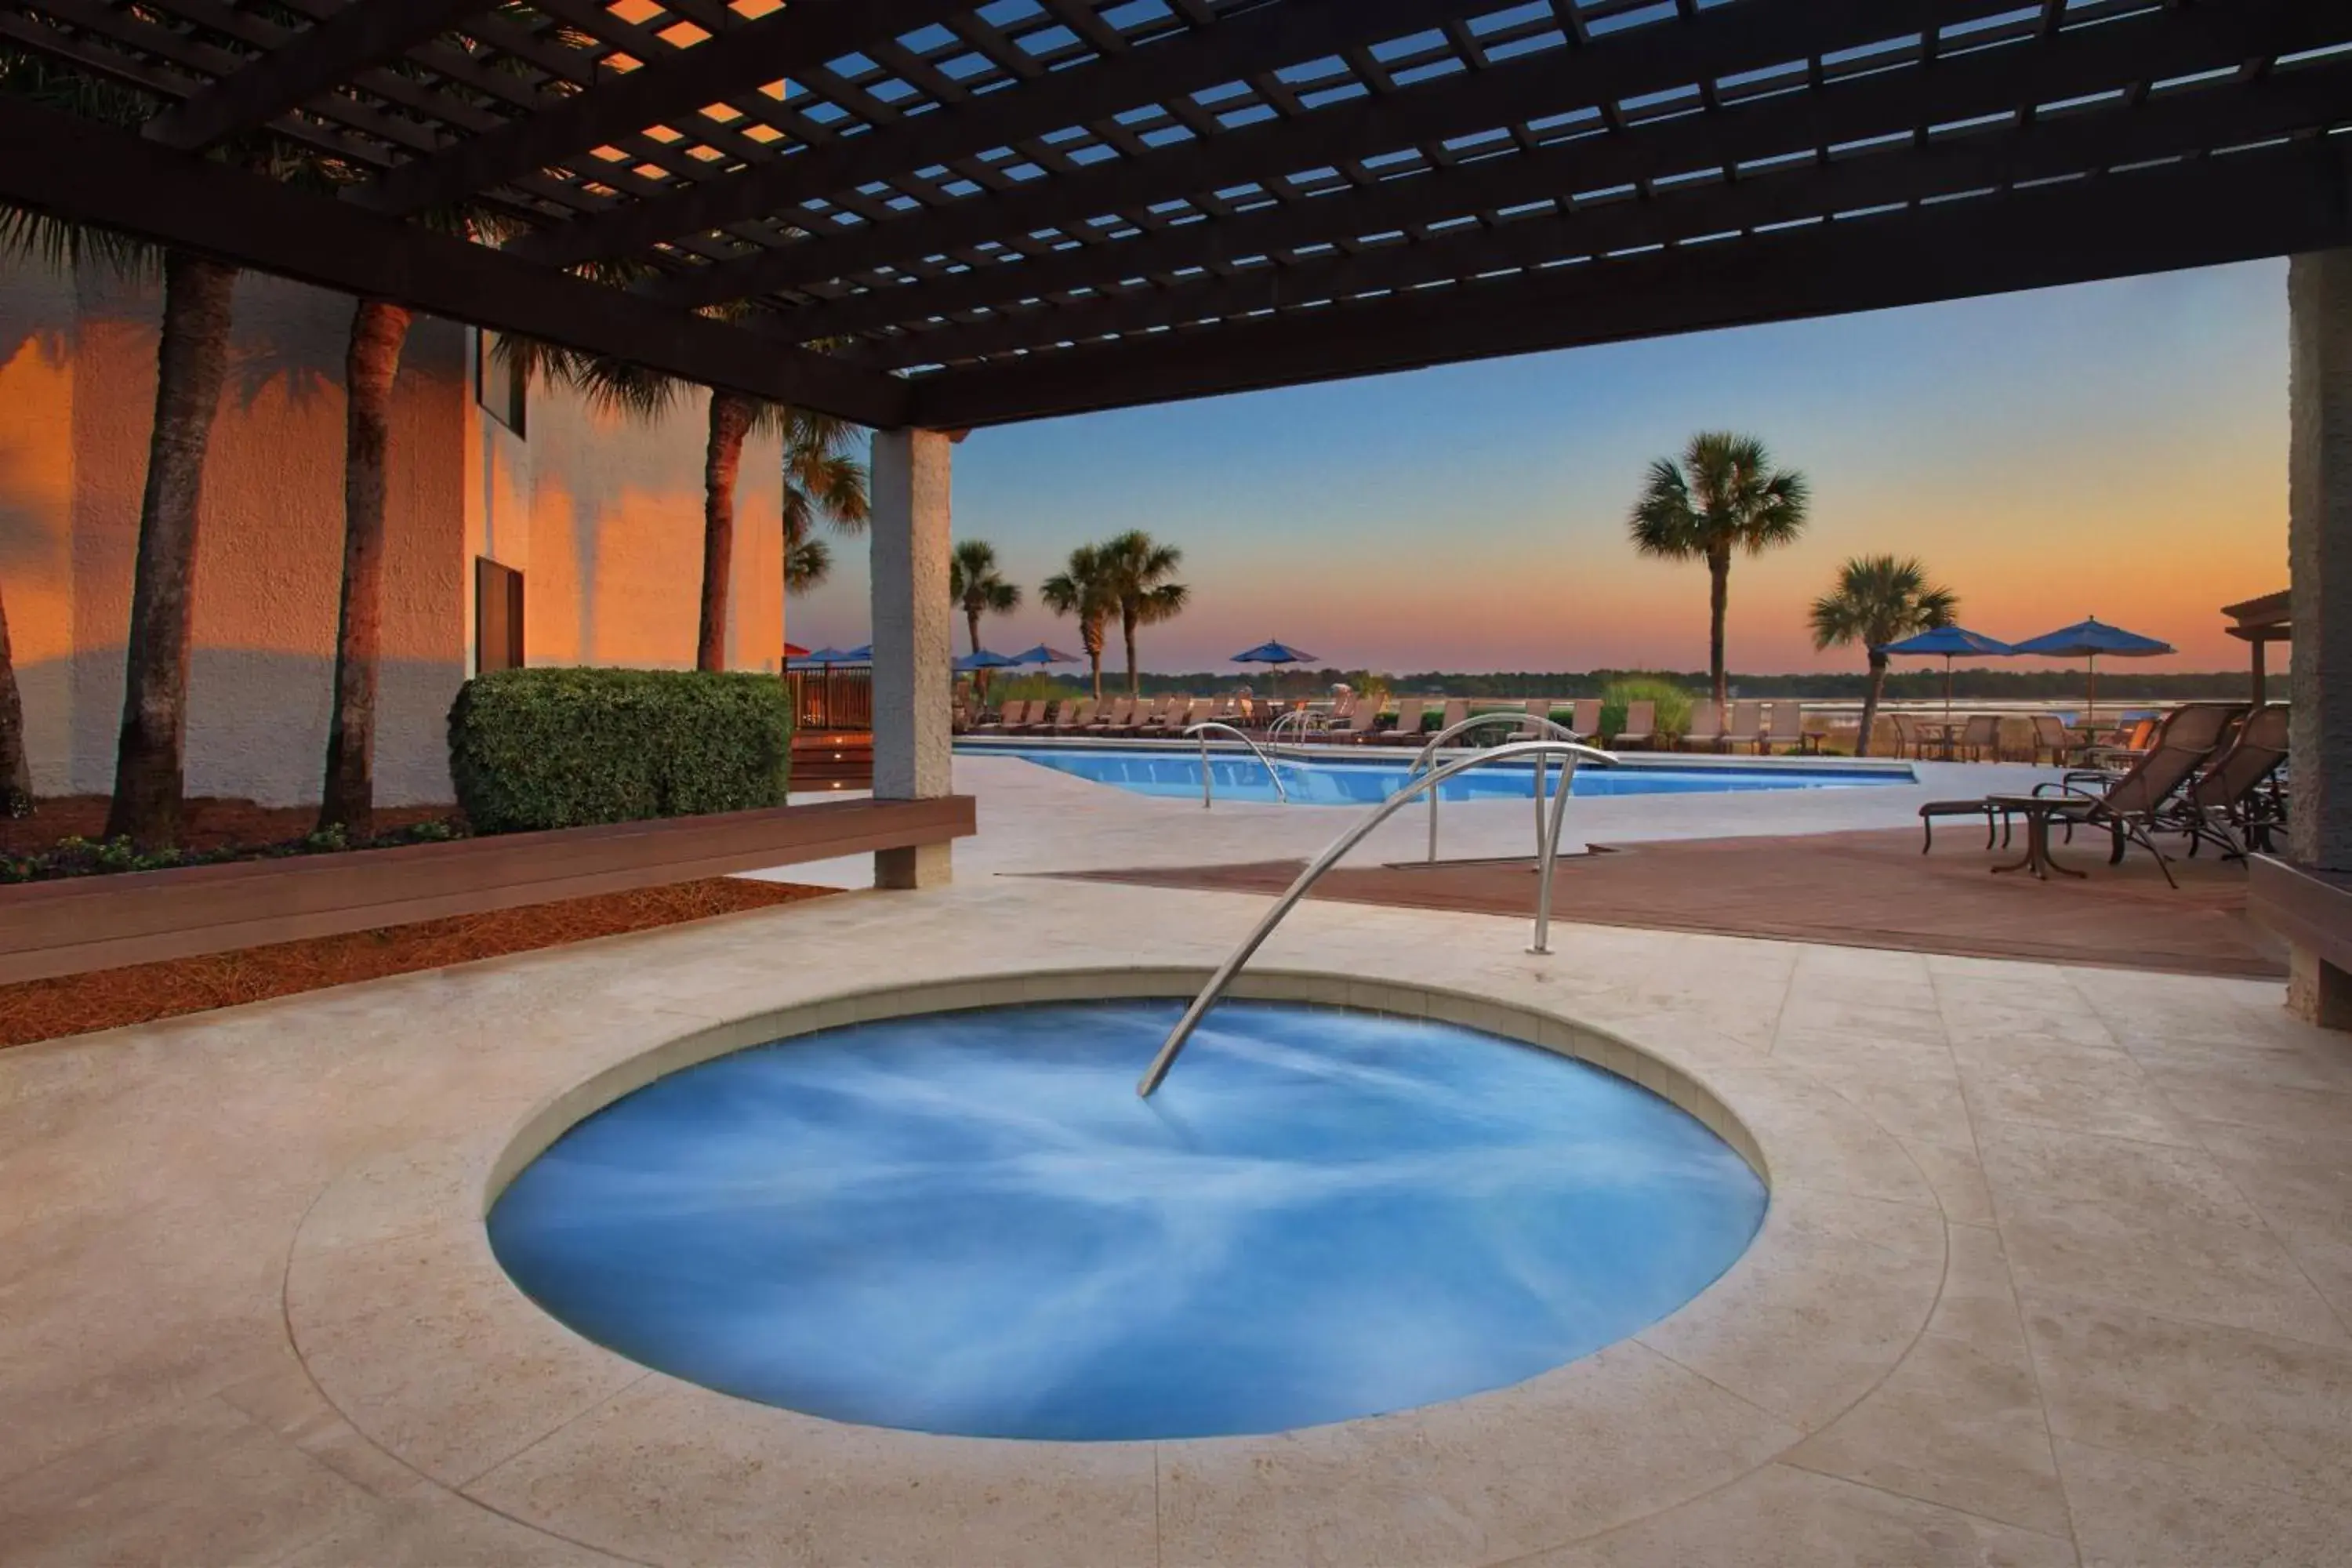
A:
[1630,430,1811,706]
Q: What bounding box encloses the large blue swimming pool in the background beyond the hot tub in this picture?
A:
[957,743,1912,806]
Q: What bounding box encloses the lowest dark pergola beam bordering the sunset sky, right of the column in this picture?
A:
[910,136,2352,430]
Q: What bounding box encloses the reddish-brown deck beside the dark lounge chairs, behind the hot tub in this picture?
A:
[1058,827,2286,978]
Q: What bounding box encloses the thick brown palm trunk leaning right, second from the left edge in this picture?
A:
[106,252,238,844]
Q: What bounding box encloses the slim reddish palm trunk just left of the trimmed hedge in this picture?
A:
[318,299,409,839]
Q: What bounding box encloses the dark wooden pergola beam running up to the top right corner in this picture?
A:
[783,0,2328,345]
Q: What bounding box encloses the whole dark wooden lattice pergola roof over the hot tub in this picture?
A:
[0,0,2352,430]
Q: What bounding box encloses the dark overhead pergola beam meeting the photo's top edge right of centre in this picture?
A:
[649,0,2016,306]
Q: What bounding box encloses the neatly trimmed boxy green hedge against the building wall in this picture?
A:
[449,670,793,832]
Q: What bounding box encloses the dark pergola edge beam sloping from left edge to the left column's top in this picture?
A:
[0,94,910,426]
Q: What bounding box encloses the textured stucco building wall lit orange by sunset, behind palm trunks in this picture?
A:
[0,255,781,804]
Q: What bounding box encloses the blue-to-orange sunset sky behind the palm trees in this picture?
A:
[790,261,2286,673]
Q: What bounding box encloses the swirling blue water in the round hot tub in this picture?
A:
[489,1001,1766,1441]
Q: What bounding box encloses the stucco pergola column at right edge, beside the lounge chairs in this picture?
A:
[2286,249,2352,1027]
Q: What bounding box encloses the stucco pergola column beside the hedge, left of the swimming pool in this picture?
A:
[870,430,955,888]
